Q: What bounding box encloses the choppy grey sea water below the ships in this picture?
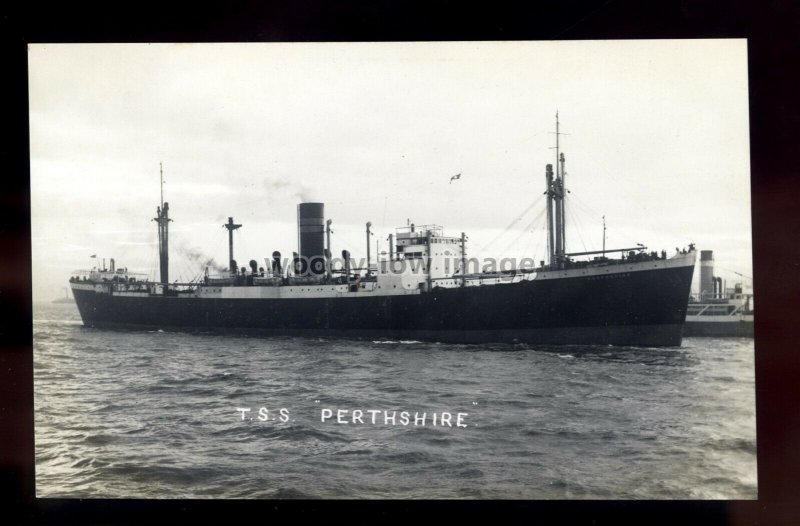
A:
[33,304,757,499]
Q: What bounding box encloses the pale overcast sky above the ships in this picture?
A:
[29,40,752,300]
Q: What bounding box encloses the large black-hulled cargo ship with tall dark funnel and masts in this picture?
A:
[70,120,695,346]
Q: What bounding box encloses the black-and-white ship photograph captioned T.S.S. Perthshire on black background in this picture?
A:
[28,38,759,501]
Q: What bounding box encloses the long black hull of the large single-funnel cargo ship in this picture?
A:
[73,266,693,346]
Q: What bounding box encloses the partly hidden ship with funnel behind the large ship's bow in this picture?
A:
[683,250,755,338]
